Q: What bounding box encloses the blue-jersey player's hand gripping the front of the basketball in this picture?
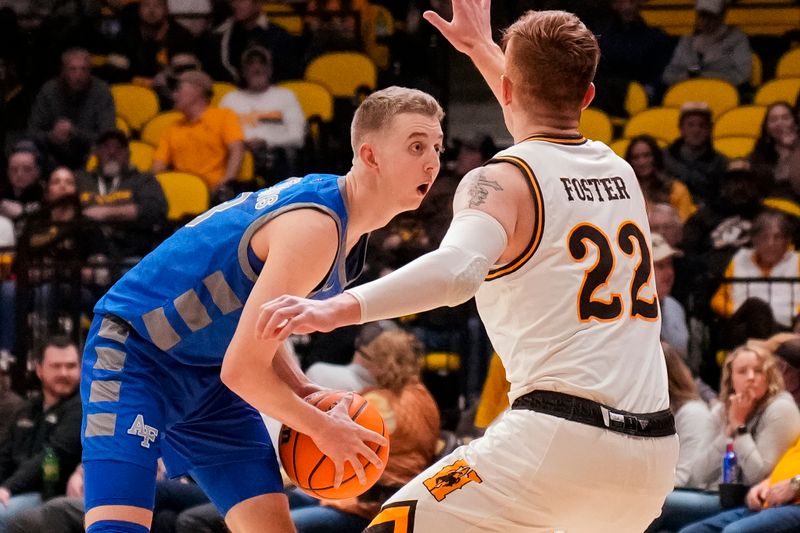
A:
[310,393,389,488]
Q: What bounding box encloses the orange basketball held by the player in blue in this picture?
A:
[278,391,389,500]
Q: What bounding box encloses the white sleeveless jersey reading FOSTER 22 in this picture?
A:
[476,137,669,413]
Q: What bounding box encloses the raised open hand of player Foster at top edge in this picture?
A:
[422,0,493,55]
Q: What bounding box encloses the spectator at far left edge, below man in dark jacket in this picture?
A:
[0,142,44,222]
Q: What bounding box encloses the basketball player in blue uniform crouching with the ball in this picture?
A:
[81,87,443,533]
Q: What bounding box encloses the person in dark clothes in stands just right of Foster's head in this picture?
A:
[593,0,673,117]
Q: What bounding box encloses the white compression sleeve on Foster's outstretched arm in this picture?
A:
[346,209,508,324]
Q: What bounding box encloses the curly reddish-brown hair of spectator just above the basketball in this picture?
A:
[359,329,422,394]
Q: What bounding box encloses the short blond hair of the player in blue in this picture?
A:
[350,86,444,157]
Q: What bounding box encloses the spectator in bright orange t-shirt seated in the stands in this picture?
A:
[152,70,249,201]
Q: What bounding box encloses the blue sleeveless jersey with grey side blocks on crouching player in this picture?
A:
[94,174,366,366]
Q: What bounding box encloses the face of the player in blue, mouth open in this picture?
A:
[375,113,444,210]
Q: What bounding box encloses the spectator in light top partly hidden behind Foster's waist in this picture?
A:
[661,342,714,488]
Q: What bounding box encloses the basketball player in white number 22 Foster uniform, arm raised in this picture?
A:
[258,0,678,533]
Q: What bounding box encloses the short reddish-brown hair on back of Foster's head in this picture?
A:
[502,11,600,113]
